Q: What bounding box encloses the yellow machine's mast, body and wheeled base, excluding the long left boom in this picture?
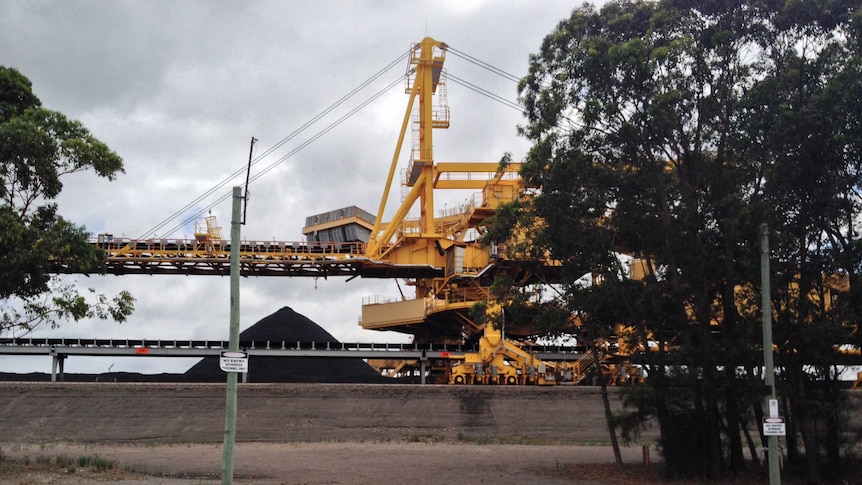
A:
[303,37,584,384]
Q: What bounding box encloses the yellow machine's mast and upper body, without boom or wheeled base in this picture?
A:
[344,38,548,343]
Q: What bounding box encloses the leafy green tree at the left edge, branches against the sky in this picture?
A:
[0,66,134,334]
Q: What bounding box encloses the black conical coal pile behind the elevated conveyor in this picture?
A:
[183,307,385,383]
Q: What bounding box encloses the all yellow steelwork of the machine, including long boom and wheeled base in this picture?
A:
[79,37,862,384]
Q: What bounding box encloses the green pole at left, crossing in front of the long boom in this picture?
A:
[221,187,244,485]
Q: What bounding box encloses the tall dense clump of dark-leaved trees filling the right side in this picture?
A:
[496,0,862,479]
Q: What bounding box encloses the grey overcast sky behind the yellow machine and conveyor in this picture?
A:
[0,0,592,372]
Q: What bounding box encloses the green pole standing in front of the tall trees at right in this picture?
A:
[760,224,781,485]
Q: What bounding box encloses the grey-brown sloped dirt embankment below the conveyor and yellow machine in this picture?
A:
[0,383,654,444]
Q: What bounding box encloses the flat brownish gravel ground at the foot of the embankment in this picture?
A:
[0,442,656,485]
